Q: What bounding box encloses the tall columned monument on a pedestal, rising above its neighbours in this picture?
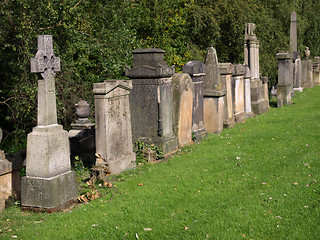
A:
[244,23,269,114]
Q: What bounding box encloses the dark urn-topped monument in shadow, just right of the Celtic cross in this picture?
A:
[68,100,95,154]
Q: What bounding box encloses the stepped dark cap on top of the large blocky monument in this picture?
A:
[126,48,174,78]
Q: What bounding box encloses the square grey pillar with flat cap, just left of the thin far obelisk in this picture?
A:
[276,52,293,107]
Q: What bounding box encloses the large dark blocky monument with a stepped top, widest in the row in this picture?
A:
[126,48,178,156]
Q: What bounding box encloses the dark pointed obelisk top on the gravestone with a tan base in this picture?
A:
[203,47,225,96]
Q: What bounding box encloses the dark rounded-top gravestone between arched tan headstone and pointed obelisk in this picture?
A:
[182,61,207,141]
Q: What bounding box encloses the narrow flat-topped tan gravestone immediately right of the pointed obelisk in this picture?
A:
[218,63,235,128]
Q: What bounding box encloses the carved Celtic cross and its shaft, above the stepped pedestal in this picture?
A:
[30,35,60,126]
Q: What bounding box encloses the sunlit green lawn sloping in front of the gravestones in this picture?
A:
[0,86,320,239]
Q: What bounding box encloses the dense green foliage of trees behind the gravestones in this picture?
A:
[0,0,320,152]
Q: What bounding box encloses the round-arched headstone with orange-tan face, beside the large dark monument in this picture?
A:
[172,73,193,147]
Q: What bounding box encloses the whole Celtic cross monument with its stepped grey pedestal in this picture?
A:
[21,35,77,211]
